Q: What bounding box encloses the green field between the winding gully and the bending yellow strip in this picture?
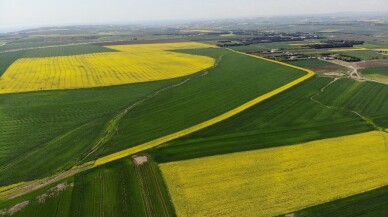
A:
[88,49,306,162]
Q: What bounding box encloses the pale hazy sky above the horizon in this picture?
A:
[0,0,388,30]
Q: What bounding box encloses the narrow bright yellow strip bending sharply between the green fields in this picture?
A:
[91,50,315,165]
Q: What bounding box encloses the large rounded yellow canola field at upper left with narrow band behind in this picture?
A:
[0,42,215,94]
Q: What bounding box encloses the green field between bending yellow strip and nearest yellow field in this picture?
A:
[150,77,378,162]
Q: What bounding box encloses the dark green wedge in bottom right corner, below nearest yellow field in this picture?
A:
[292,186,388,217]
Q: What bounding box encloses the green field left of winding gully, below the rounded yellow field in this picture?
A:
[0,76,182,186]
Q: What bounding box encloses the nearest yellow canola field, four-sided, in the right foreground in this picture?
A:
[160,132,388,216]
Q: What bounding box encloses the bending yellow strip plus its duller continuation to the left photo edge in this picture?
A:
[0,48,314,199]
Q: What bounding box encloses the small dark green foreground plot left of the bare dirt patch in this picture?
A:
[70,158,146,216]
